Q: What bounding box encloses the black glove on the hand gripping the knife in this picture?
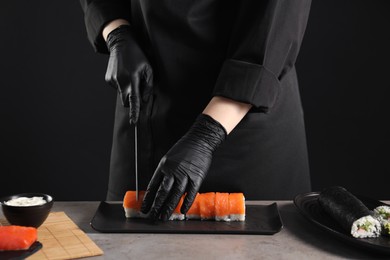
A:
[106,25,153,124]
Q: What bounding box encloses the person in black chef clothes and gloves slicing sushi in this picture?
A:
[81,0,311,220]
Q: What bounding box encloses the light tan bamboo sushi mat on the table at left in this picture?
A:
[0,212,103,260]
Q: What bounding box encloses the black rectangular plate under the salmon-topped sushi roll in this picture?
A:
[91,201,283,235]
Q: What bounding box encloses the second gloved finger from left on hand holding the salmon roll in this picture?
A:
[149,174,175,220]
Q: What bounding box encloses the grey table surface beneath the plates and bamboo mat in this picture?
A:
[0,201,390,260]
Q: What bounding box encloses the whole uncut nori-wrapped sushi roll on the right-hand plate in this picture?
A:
[318,187,381,238]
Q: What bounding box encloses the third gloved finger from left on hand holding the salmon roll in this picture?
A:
[161,177,188,221]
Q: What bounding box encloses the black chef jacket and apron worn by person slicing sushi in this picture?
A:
[81,0,311,200]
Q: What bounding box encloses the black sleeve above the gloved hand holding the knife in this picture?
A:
[80,0,131,53]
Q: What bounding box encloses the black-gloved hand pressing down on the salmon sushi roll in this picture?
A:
[141,114,227,220]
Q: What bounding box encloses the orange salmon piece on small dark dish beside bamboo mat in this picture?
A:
[0,226,37,251]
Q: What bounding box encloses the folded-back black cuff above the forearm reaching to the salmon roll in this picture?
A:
[213,59,280,111]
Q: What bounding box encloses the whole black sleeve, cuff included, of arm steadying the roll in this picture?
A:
[213,0,311,111]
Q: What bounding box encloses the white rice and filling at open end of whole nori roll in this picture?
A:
[351,215,381,238]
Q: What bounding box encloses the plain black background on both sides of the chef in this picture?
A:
[0,0,390,200]
